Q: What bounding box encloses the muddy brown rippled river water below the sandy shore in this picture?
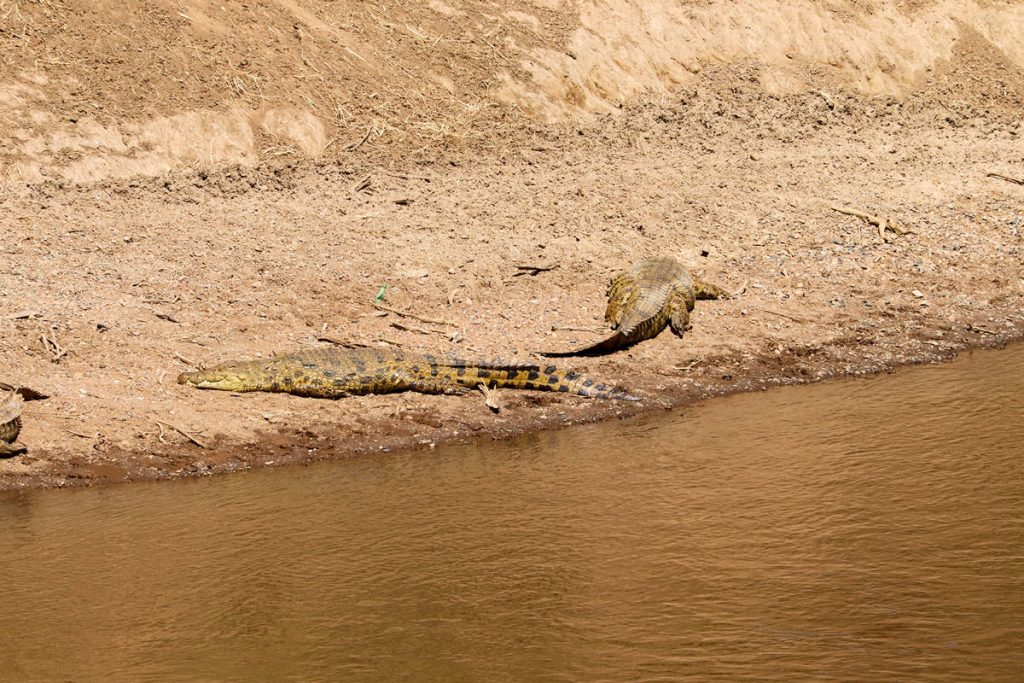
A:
[0,345,1024,681]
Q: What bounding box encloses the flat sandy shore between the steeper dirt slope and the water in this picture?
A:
[0,3,1024,488]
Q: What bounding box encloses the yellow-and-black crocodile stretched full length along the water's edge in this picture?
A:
[178,348,639,400]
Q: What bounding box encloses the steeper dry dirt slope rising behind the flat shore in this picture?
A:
[0,0,1024,182]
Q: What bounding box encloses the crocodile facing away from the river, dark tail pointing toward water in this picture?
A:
[541,258,729,357]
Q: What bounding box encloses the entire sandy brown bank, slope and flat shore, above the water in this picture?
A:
[0,0,1024,488]
